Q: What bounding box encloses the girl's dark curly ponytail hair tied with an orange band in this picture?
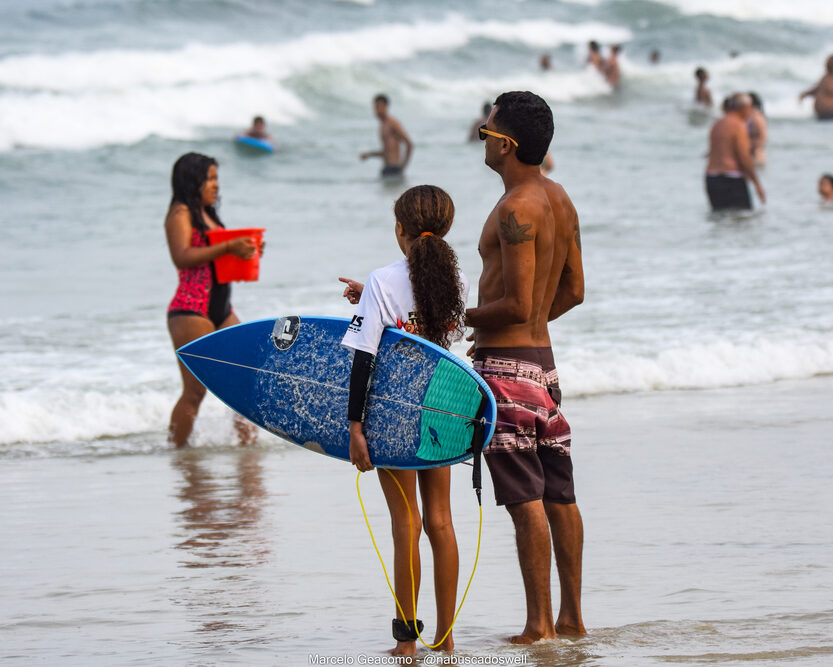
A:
[393,185,466,348]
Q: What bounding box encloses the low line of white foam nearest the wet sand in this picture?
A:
[0,337,833,446]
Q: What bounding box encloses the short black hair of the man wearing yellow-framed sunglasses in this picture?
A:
[494,90,553,164]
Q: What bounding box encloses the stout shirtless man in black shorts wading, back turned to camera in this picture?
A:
[706,93,766,211]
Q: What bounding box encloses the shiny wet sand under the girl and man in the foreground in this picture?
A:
[0,376,833,665]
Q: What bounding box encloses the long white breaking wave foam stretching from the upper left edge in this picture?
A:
[0,16,630,150]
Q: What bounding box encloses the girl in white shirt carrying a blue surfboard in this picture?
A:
[340,185,468,655]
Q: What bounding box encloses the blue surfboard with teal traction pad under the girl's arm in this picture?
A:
[177,316,497,468]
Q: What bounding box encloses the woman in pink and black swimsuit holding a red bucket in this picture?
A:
[165,153,257,447]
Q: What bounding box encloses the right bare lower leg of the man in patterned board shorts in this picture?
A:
[544,502,587,635]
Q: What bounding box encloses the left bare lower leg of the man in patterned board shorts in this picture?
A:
[506,500,555,644]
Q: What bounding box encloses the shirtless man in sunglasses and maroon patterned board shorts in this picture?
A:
[466,92,586,644]
